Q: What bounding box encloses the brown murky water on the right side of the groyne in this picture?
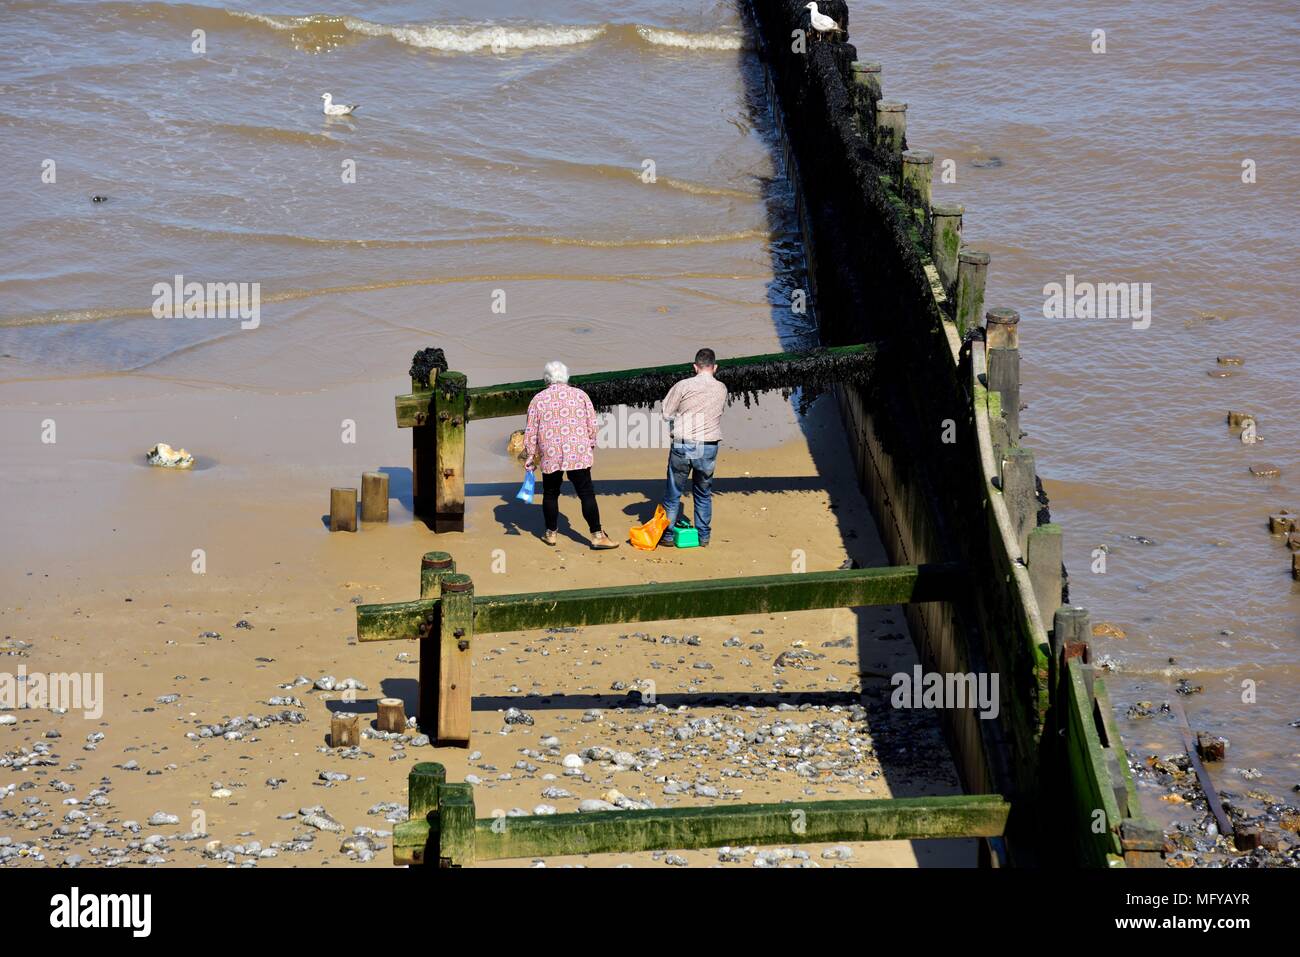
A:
[850,3,1300,837]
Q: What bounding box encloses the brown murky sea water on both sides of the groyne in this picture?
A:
[0,0,1300,852]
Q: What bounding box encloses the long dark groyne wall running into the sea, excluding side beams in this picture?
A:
[748,0,1161,866]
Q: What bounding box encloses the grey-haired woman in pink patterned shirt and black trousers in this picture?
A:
[524,363,619,549]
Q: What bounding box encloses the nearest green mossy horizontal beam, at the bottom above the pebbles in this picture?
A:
[393,794,1010,863]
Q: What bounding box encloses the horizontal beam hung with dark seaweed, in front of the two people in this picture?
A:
[397,343,876,429]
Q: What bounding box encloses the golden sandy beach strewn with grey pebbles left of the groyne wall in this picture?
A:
[0,382,974,866]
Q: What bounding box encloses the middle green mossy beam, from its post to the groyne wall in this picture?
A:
[473,564,963,637]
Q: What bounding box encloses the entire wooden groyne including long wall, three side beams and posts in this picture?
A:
[358,0,1162,866]
